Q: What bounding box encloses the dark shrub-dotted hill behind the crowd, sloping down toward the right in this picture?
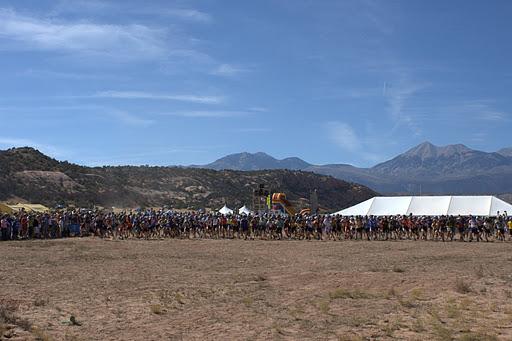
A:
[0,148,376,210]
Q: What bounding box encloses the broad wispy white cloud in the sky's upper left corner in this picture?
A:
[0,9,166,59]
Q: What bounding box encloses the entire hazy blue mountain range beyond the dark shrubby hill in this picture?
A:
[198,142,512,194]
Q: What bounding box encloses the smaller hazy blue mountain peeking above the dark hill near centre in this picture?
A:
[199,152,311,171]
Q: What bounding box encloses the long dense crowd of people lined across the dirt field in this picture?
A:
[0,210,512,242]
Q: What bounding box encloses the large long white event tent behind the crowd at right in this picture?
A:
[334,196,512,216]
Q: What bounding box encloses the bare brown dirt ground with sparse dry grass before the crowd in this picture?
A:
[0,239,512,341]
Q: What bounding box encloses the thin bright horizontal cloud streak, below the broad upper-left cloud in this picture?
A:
[93,91,224,104]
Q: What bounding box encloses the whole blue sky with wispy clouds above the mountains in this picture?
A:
[0,0,512,166]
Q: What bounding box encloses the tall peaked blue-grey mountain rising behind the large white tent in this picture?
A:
[362,142,512,194]
